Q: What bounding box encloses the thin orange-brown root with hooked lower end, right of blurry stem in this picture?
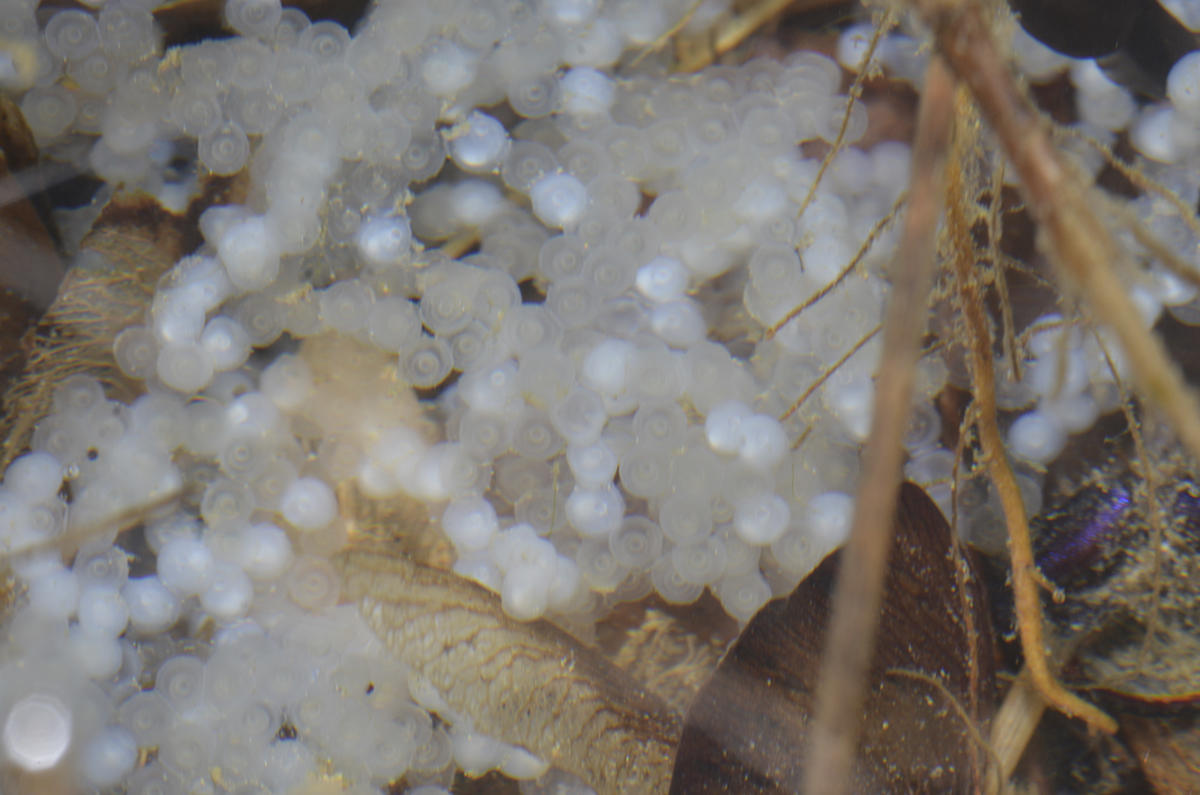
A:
[952,143,1117,734]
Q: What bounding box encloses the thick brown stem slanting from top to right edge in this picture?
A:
[911,0,1200,480]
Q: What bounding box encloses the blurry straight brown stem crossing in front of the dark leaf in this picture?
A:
[802,56,954,795]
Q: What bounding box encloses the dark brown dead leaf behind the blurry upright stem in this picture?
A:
[671,483,994,795]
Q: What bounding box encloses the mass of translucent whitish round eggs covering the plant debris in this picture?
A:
[7,0,1200,795]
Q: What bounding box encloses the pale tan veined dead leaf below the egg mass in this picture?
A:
[335,549,679,795]
